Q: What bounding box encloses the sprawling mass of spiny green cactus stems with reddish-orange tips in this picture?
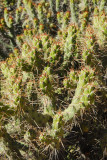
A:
[0,0,107,160]
